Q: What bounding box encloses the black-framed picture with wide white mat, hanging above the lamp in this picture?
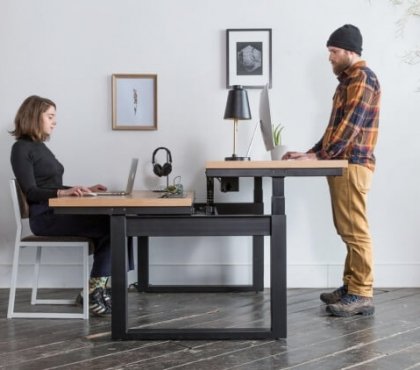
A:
[226,28,271,88]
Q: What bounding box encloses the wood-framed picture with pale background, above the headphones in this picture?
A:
[112,74,157,130]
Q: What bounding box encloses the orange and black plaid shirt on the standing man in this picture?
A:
[309,61,381,171]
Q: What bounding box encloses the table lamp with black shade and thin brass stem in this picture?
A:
[224,85,252,161]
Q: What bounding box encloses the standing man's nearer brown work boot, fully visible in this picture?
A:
[327,294,375,317]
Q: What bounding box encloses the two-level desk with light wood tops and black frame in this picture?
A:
[50,161,347,340]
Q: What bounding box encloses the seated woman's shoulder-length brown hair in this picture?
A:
[10,95,56,141]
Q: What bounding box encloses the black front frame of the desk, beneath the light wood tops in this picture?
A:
[52,167,343,340]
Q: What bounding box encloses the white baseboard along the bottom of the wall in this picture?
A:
[0,263,420,288]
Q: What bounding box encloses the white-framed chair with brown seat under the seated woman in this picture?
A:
[7,180,91,320]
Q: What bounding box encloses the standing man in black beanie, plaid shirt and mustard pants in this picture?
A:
[283,24,381,317]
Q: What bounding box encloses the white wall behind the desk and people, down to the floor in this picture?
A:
[0,0,420,287]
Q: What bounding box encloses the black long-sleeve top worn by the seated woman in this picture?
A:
[10,138,67,205]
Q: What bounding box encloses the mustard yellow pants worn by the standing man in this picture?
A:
[328,164,373,297]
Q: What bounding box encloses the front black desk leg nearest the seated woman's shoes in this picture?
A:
[111,215,128,340]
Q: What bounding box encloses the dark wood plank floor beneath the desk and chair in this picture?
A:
[0,289,420,370]
